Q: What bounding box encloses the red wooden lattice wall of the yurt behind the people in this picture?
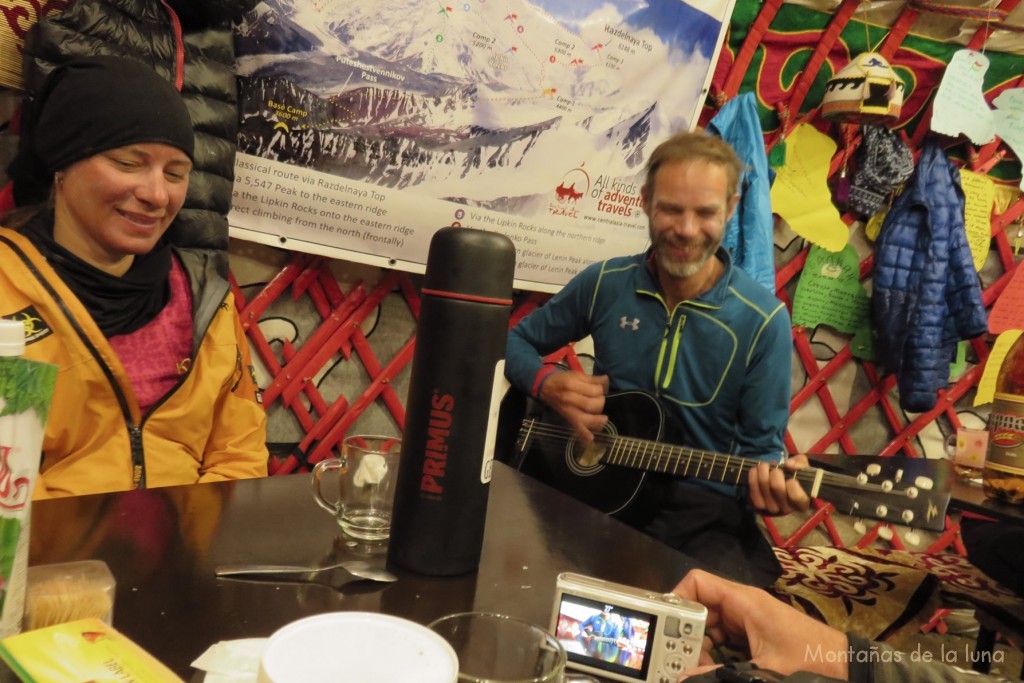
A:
[232,0,1024,554]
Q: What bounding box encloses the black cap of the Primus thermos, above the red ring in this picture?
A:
[423,227,515,303]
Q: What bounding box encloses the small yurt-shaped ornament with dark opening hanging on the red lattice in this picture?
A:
[821,52,906,124]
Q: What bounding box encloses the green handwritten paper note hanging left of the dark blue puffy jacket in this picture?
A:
[793,245,868,334]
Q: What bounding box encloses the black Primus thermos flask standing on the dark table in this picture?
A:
[388,227,515,575]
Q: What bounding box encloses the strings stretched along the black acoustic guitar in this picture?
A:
[519,420,905,493]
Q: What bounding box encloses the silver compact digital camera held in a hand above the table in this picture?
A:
[551,573,708,683]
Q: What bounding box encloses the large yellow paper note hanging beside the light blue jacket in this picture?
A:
[771,123,850,252]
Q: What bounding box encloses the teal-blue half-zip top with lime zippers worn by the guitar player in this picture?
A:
[506,249,793,491]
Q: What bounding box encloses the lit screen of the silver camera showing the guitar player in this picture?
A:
[555,593,657,681]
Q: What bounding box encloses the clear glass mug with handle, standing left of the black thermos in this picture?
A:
[312,435,401,541]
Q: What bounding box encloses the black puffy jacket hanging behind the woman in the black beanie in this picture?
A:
[15,0,256,249]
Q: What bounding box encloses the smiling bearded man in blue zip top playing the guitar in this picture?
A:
[506,132,810,586]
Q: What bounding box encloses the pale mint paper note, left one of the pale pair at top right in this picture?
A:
[932,50,995,144]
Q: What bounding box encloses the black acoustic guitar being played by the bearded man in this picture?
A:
[510,391,949,531]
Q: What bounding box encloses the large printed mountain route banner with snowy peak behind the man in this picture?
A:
[228,0,732,291]
